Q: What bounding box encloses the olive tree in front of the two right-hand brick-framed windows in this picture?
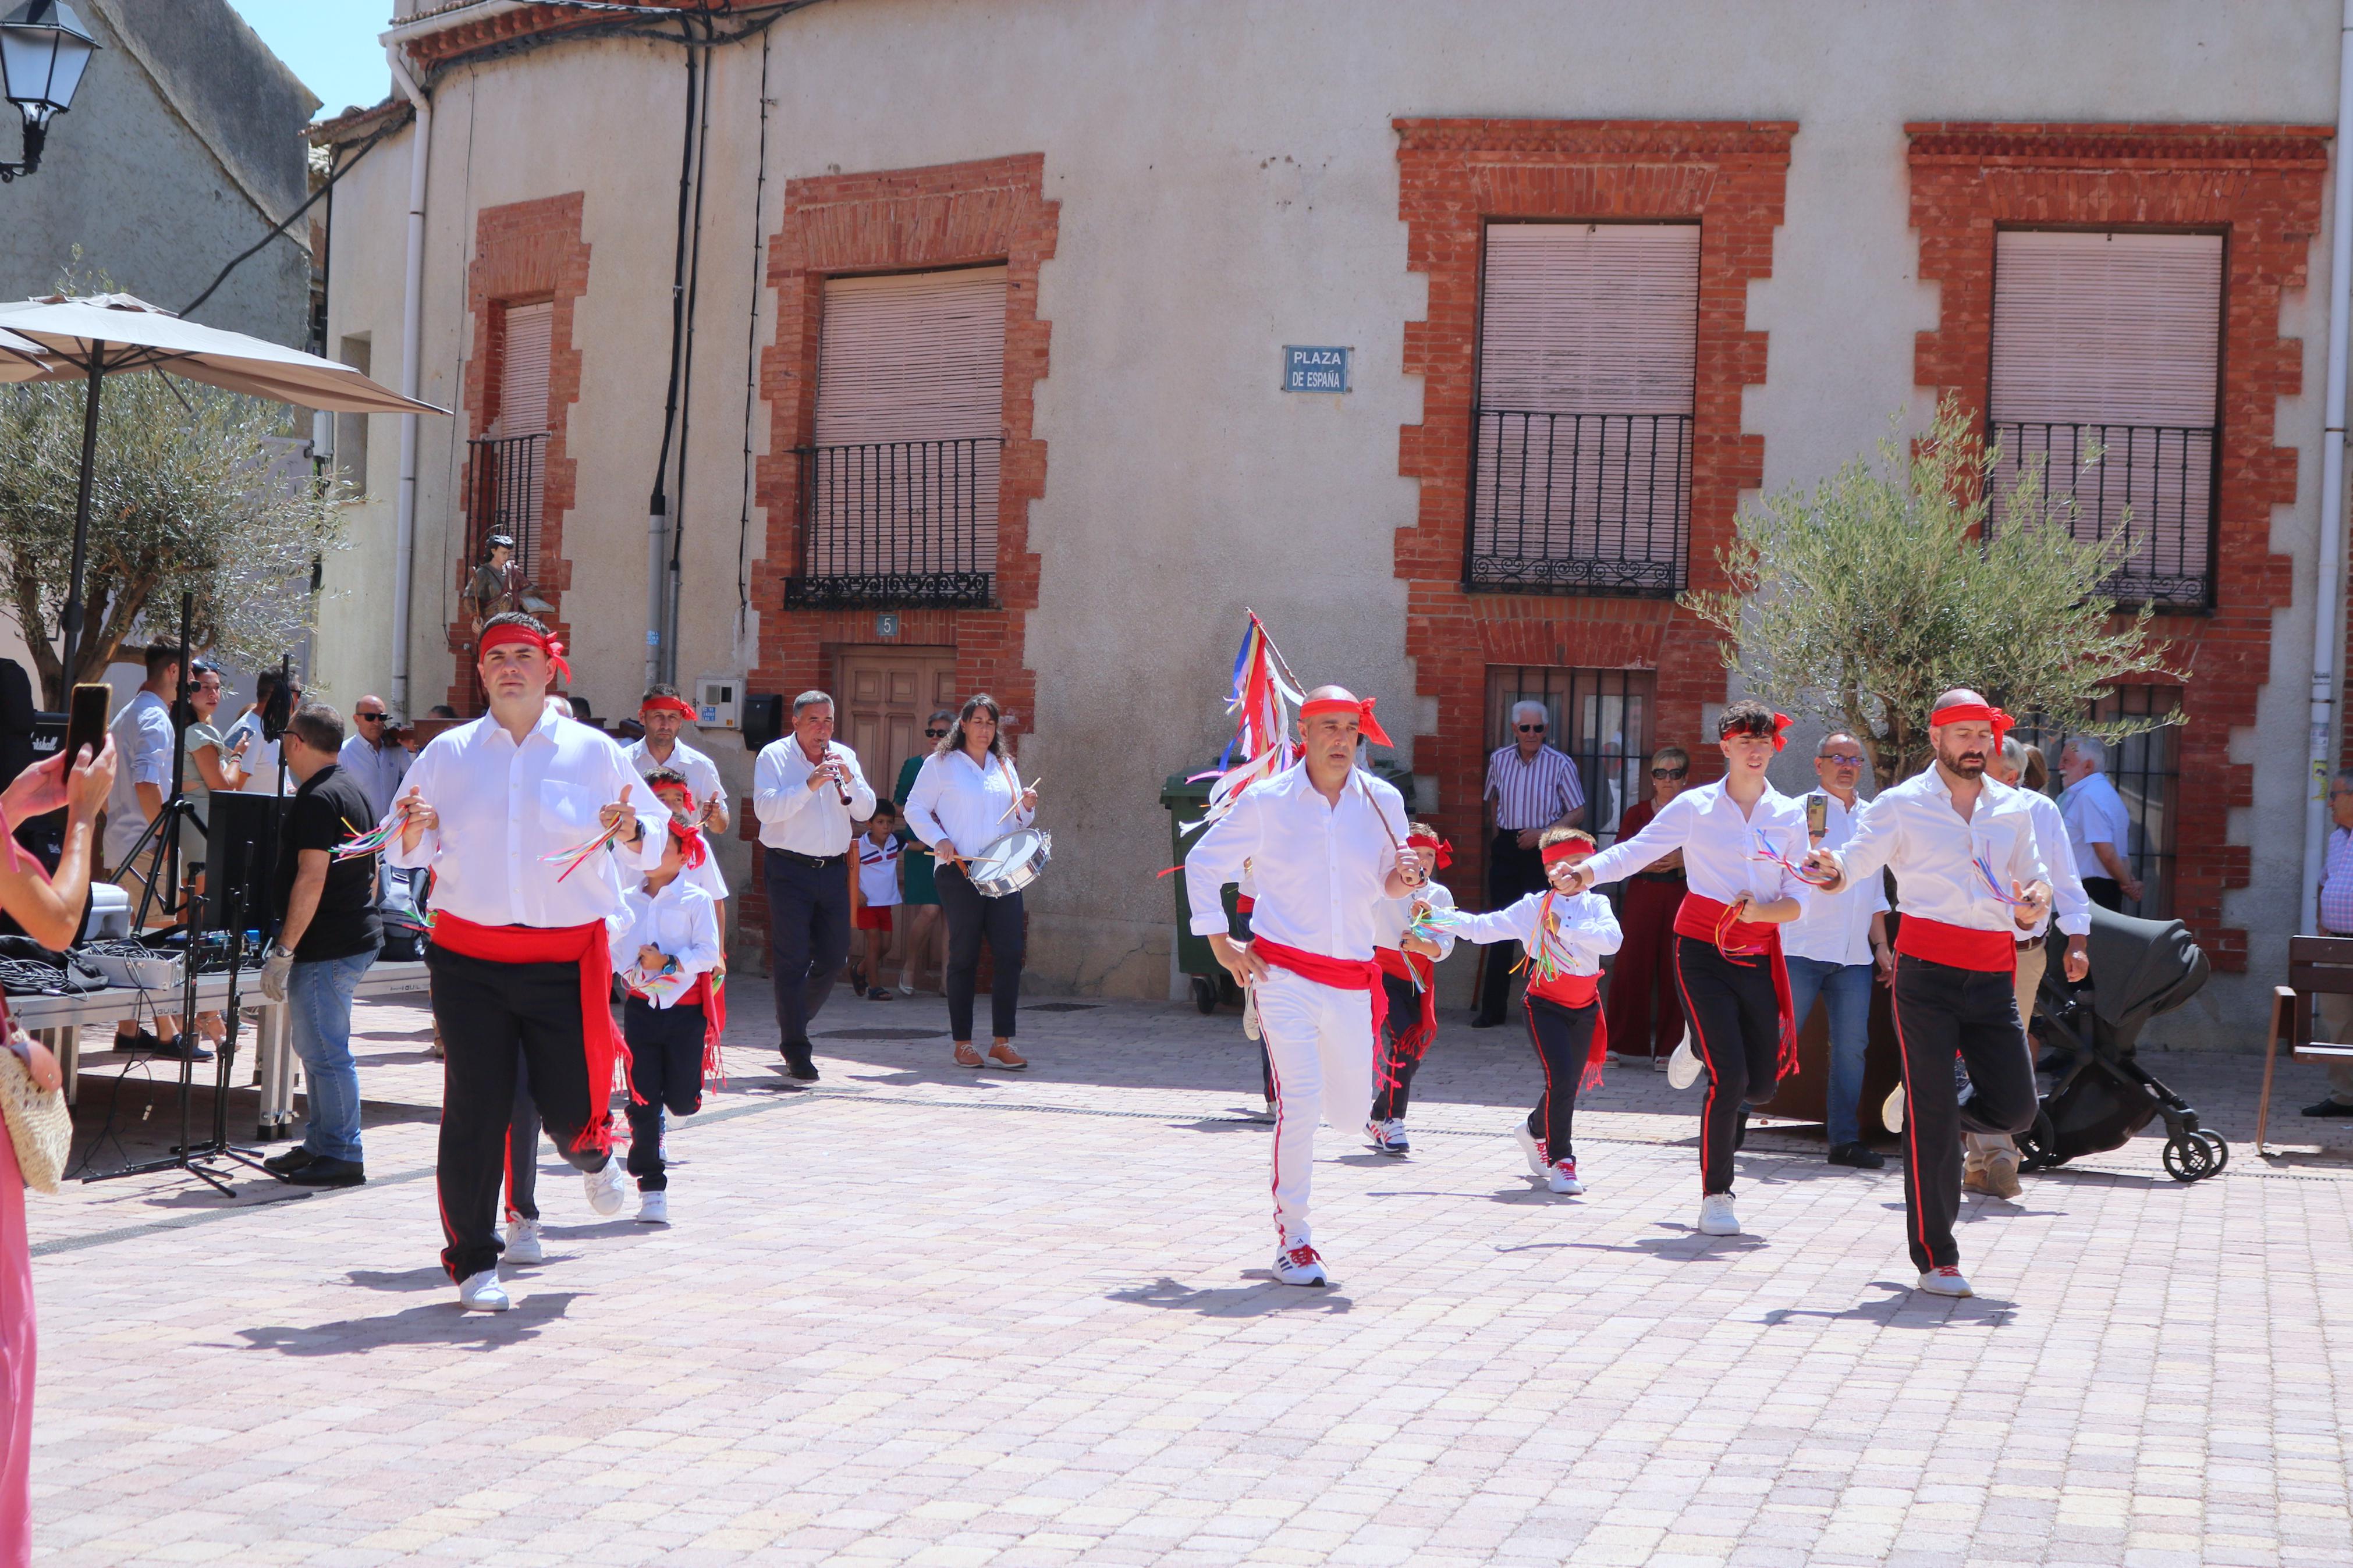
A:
[1683,397,2186,780]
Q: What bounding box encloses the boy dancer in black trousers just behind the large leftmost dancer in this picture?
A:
[621,799,720,1225]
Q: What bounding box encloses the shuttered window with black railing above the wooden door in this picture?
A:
[786,266,1007,604]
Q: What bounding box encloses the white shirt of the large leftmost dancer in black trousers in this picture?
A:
[384,712,668,931]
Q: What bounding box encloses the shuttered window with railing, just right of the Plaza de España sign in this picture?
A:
[1466,223,1699,595]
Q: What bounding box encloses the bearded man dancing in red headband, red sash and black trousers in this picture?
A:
[1807,689,2061,1295]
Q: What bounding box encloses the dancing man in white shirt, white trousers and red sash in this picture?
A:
[1184,687,1424,1286]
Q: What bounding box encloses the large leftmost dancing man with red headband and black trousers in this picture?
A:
[386,611,668,1312]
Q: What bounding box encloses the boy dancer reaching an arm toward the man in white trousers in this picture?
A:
[1454,827,1621,1197]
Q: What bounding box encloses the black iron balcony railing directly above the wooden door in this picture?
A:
[783,435,1005,609]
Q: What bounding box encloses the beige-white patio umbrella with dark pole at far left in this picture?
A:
[0,294,447,670]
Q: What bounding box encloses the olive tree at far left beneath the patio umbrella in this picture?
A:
[0,371,343,710]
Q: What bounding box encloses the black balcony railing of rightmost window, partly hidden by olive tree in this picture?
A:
[1990,418,2219,609]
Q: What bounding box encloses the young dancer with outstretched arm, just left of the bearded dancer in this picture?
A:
[1555,701,1809,1236]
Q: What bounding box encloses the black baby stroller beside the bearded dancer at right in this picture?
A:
[2019,908,2231,1182]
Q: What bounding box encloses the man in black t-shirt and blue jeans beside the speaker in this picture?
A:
[261,703,384,1187]
